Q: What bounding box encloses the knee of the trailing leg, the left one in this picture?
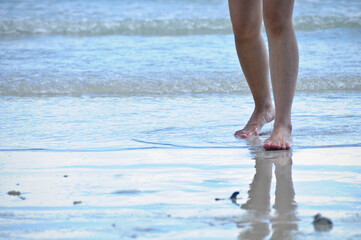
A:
[232,15,261,41]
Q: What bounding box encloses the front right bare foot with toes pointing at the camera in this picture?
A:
[263,125,293,150]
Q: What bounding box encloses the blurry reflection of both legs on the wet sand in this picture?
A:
[238,149,298,239]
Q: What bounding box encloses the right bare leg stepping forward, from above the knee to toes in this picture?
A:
[263,0,298,150]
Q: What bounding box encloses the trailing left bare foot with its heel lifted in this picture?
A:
[234,106,275,138]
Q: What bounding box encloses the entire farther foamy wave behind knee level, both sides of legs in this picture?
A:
[0,16,361,36]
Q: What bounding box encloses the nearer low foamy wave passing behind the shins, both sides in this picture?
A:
[0,74,361,97]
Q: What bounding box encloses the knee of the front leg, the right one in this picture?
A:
[263,7,293,37]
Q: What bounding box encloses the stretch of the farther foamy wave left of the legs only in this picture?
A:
[0,19,232,36]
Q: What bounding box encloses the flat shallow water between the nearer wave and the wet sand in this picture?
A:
[0,92,361,151]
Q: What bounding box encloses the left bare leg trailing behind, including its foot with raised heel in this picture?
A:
[229,0,274,138]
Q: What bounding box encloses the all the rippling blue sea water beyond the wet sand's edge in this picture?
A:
[0,0,361,151]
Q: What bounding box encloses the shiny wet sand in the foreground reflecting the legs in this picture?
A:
[0,145,361,239]
